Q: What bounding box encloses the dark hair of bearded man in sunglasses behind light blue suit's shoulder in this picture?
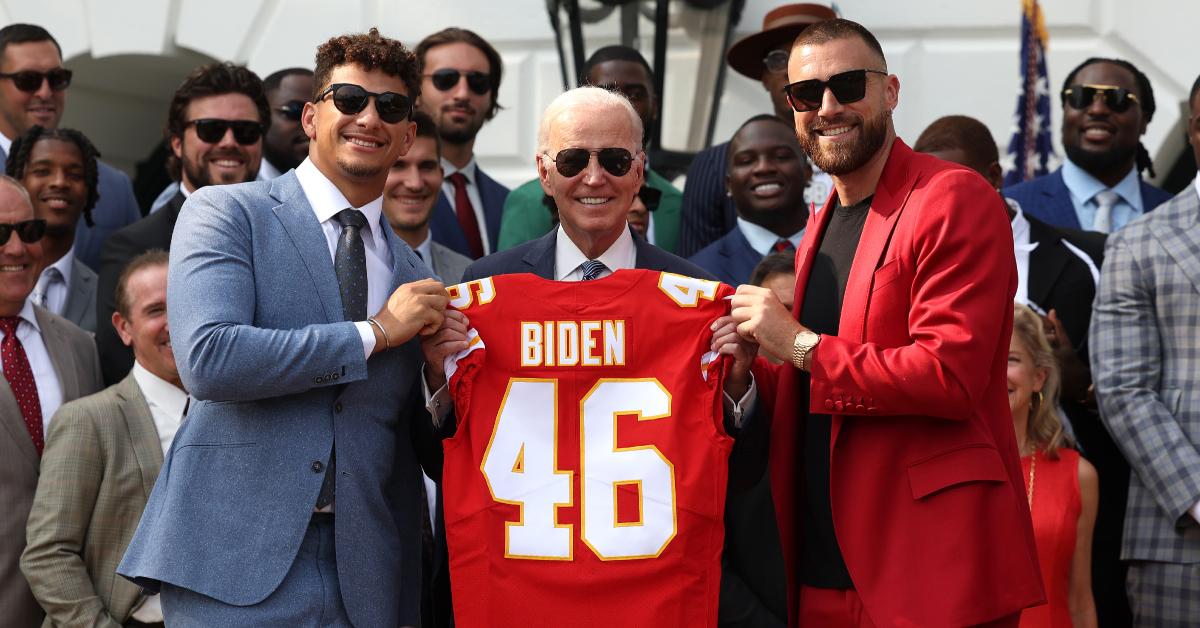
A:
[163,61,271,181]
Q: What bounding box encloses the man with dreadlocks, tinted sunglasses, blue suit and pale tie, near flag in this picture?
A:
[1003,58,1171,233]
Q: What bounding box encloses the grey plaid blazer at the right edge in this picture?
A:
[1090,185,1200,562]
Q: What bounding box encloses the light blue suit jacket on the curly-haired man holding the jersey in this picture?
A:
[118,172,440,626]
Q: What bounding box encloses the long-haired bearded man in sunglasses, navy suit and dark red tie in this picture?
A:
[416,28,509,259]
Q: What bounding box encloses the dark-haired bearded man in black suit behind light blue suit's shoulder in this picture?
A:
[96,62,271,385]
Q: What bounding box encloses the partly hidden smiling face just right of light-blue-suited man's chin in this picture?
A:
[383,137,443,233]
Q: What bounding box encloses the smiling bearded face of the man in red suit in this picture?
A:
[787,37,900,177]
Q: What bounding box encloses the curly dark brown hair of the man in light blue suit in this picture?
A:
[312,26,421,109]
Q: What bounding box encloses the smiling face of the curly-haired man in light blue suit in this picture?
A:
[301,64,415,196]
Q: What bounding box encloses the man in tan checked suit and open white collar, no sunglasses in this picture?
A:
[20,251,187,628]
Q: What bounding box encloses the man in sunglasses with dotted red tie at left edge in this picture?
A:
[0,175,101,628]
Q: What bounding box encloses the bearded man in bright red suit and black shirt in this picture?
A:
[732,19,1044,627]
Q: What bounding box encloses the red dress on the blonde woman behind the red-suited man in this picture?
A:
[1021,448,1082,628]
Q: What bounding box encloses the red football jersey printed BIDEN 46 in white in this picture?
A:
[443,270,733,628]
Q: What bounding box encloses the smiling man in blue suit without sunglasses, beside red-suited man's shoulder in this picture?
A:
[691,114,809,286]
